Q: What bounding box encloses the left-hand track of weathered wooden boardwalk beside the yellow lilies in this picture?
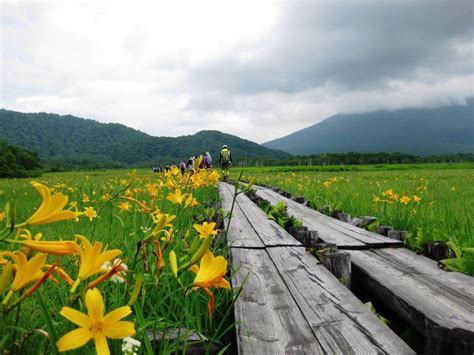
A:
[219,183,413,354]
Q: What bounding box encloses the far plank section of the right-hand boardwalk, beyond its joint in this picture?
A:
[255,186,403,249]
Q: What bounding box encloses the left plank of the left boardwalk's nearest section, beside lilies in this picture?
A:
[231,248,324,354]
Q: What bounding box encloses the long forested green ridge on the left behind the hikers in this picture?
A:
[0,110,289,165]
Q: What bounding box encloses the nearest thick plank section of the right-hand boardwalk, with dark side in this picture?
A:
[348,249,474,353]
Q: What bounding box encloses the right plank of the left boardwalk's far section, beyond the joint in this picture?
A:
[220,183,302,247]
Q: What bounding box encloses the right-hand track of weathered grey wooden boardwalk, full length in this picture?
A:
[256,187,474,354]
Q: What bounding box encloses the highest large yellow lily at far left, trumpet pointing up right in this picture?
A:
[16,182,76,228]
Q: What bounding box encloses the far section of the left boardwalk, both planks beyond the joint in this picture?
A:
[219,183,302,248]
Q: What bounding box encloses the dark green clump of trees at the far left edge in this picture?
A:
[0,141,41,178]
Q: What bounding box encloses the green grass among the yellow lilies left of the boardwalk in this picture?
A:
[0,170,238,354]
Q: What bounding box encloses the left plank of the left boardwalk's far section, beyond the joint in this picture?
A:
[219,184,265,248]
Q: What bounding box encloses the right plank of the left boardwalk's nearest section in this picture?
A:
[267,247,414,354]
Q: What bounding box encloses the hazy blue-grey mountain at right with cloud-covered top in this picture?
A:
[263,99,474,155]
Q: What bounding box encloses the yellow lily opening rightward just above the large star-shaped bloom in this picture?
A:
[71,235,122,292]
